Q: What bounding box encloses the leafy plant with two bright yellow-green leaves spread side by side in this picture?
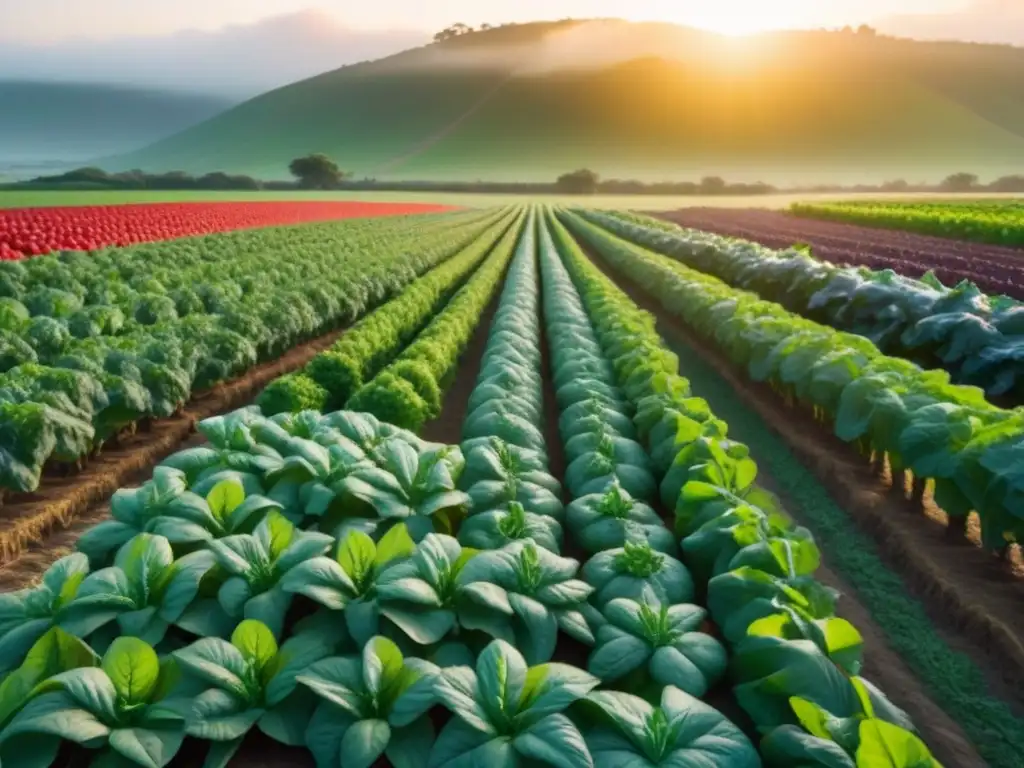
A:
[281,523,416,647]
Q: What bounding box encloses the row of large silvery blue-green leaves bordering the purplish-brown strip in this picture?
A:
[582,211,1024,399]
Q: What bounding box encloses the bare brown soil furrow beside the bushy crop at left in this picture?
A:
[0,331,342,589]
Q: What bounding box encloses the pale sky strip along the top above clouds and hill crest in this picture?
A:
[0,0,974,42]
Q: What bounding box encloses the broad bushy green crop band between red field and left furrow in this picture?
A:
[0,205,499,490]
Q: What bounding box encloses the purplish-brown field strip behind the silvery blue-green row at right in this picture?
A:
[651,208,1024,298]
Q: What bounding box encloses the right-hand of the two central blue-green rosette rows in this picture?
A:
[540,215,760,766]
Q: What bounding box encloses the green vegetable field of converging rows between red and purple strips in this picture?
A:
[0,201,1024,768]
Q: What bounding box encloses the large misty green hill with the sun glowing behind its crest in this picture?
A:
[108,22,1024,182]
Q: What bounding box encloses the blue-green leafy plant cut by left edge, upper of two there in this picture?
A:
[0,552,89,674]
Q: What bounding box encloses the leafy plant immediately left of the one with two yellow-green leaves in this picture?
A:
[208,511,334,637]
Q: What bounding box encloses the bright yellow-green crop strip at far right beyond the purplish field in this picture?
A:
[791,203,1024,246]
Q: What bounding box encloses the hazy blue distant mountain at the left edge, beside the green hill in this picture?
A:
[0,80,233,177]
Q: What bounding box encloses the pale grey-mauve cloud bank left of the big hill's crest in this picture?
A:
[0,10,430,101]
